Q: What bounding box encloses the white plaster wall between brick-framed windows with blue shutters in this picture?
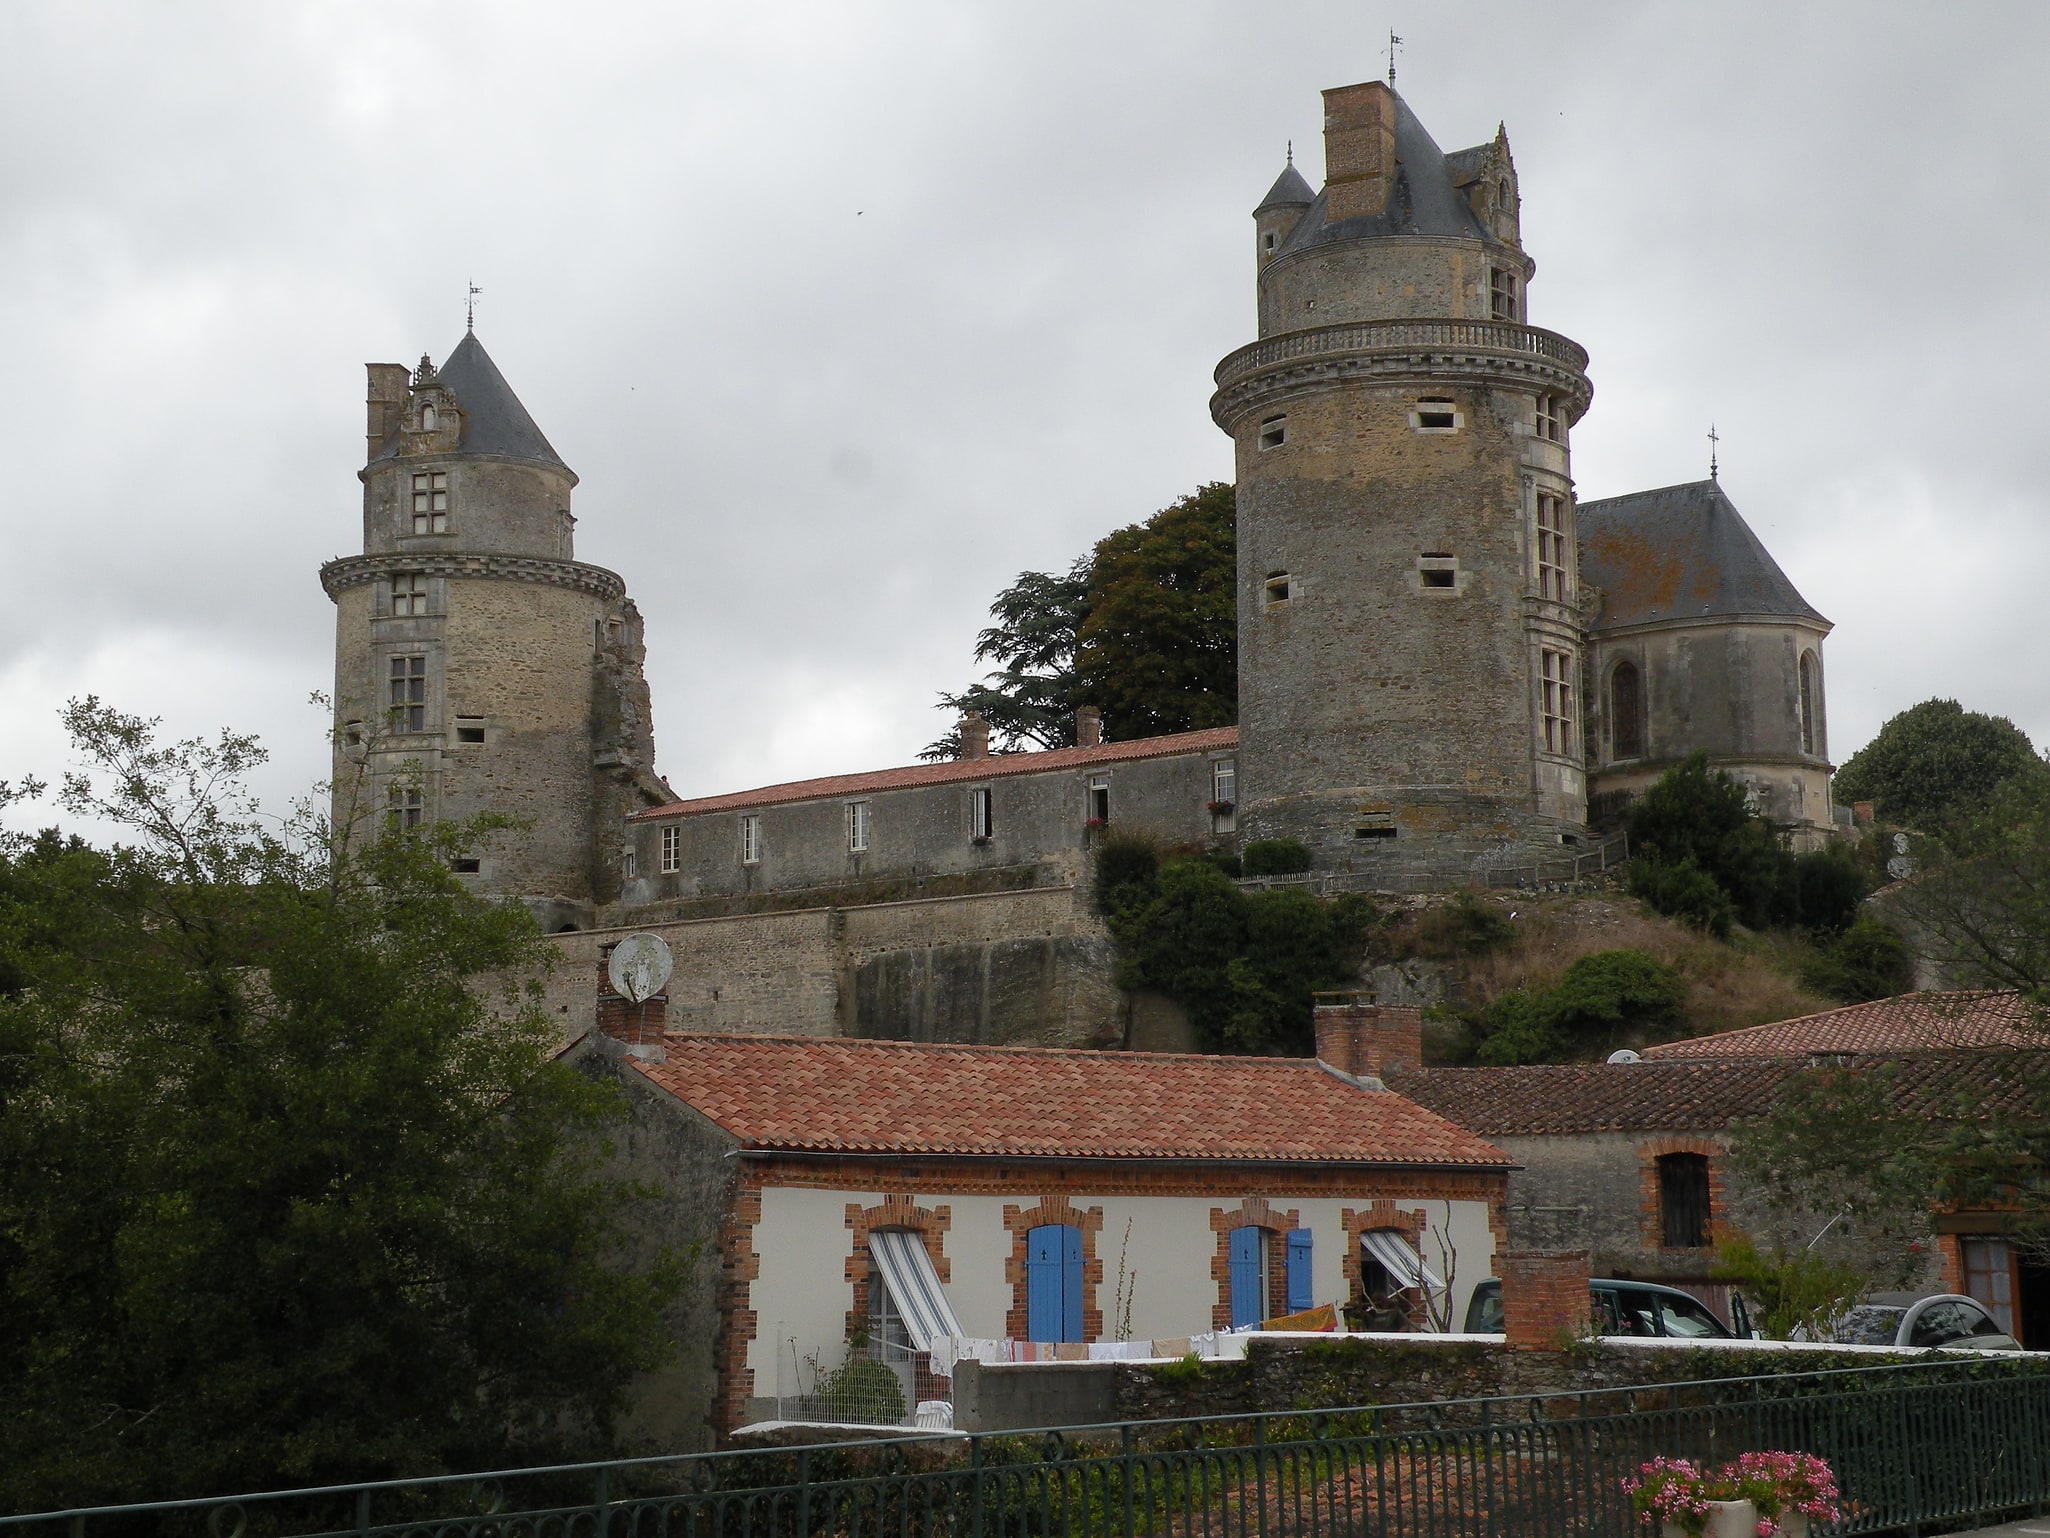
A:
[748,1185,1494,1394]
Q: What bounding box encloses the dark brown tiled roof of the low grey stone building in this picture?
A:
[1390,1050,2050,1138]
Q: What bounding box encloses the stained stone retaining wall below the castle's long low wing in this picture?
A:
[545,886,1128,1046]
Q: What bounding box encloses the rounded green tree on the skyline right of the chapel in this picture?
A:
[1833,699,2050,826]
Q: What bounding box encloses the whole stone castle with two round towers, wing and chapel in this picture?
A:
[322,82,1833,1044]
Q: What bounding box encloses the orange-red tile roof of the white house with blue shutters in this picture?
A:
[633,1034,1513,1169]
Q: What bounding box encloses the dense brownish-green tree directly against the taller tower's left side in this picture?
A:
[1074,482,1238,740]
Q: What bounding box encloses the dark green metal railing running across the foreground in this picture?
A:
[0,1358,2050,1538]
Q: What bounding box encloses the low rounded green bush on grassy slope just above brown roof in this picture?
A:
[1474,949,1687,1064]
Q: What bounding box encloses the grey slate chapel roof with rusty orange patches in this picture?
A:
[1579,480,1829,630]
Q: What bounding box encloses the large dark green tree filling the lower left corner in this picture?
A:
[0,699,677,1509]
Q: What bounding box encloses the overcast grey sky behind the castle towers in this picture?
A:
[0,0,2050,844]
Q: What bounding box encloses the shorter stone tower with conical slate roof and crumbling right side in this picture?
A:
[320,332,672,931]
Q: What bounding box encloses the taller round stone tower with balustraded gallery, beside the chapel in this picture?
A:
[1212,82,1591,880]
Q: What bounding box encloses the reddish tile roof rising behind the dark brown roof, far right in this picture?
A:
[1644,990,2050,1062]
